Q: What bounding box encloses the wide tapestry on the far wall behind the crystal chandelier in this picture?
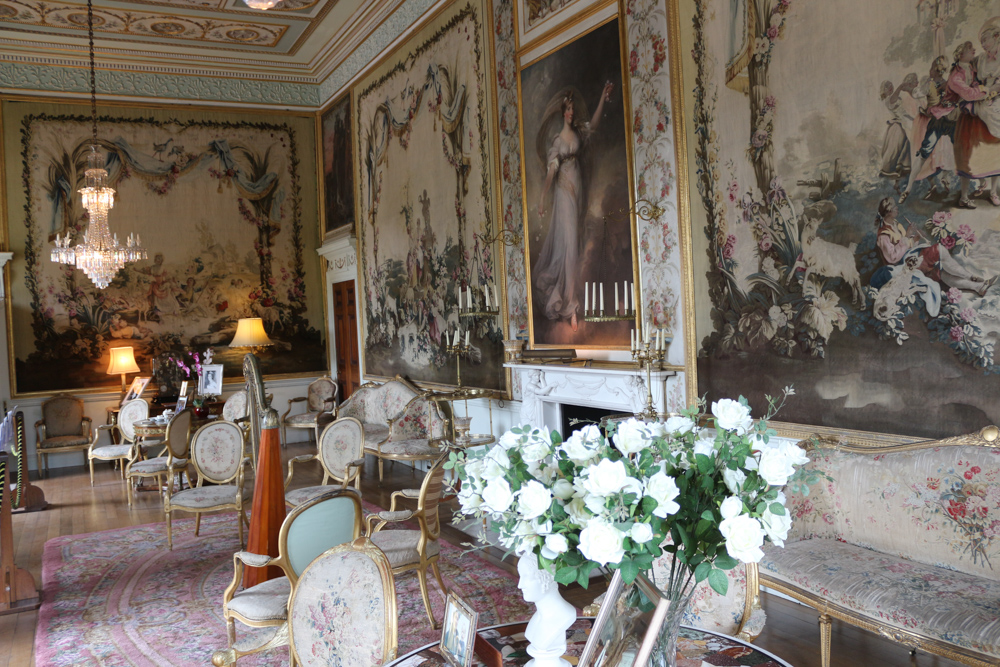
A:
[3,102,327,394]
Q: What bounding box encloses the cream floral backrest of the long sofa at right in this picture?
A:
[785,446,1000,581]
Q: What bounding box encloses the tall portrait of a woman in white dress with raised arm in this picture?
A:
[520,18,637,348]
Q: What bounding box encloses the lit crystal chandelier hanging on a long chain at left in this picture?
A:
[52,0,147,289]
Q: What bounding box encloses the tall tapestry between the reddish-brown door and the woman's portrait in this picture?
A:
[355,2,507,391]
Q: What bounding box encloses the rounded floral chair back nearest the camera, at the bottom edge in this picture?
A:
[288,537,397,667]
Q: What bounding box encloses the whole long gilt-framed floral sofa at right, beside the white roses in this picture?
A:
[760,426,1000,667]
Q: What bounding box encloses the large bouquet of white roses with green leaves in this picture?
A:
[447,388,808,594]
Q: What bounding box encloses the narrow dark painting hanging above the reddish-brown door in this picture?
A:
[320,95,354,234]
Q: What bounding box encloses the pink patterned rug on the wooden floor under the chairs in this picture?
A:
[35,503,534,667]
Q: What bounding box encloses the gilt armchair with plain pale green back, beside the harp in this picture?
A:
[212,489,366,667]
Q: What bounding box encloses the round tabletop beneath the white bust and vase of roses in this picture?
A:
[387,618,792,667]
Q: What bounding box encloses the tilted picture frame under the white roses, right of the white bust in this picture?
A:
[577,570,670,667]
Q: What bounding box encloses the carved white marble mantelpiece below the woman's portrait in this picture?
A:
[505,364,676,430]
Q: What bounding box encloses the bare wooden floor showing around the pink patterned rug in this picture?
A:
[0,443,959,667]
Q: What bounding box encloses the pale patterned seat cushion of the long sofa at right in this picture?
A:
[760,538,1000,657]
